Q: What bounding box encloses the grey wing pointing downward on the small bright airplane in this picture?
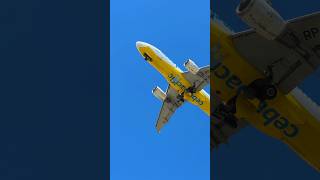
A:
[156,85,183,133]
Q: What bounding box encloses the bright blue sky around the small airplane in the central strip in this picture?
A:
[110,0,210,180]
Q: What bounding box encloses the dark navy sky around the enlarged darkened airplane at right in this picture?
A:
[211,0,320,180]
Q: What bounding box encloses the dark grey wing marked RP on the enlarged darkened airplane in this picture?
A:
[231,12,320,93]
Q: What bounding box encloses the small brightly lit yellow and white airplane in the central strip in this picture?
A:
[136,41,210,133]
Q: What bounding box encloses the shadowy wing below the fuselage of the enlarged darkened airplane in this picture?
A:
[210,93,247,149]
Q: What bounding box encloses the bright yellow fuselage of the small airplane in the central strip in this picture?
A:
[138,44,210,115]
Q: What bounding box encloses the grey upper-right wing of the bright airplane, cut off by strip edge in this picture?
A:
[183,66,210,91]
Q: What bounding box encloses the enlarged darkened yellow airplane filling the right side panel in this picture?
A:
[210,0,320,171]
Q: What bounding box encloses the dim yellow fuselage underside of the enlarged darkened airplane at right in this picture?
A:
[210,21,320,171]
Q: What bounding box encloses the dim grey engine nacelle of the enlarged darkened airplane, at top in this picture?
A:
[236,0,286,40]
